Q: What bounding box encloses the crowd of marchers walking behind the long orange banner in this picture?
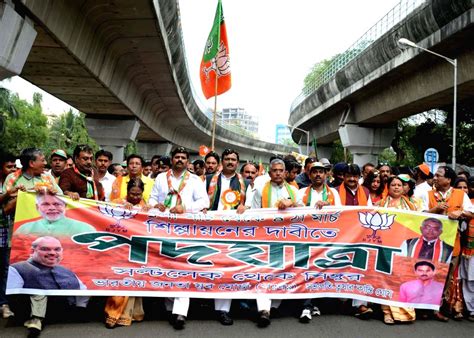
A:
[0,145,474,334]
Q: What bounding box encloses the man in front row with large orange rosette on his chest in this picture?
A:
[206,149,245,325]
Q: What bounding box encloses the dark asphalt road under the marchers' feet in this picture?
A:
[0,304,474,338]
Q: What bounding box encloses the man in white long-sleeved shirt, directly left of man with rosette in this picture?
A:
[149,147,209,330]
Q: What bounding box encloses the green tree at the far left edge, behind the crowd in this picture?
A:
[1,94,48,154]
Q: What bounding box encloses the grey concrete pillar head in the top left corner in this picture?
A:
[0,0,37,81]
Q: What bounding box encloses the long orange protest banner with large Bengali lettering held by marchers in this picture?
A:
[7,192,457,309]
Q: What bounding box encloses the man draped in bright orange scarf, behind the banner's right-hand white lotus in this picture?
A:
[337,164,374,319]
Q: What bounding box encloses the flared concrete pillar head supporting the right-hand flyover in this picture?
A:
[339,124,396,166]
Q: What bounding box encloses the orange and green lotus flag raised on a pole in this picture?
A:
[200,0,231,99]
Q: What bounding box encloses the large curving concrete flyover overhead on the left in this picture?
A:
[0,0,295,160]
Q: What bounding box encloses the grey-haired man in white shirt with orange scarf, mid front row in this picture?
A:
[251,159,299,327]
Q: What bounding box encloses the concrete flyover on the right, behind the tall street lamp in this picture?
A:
[288,0,474,163]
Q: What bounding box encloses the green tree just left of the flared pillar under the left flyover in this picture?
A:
[45,109,99,154]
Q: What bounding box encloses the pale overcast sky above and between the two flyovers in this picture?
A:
[2,0,399,141]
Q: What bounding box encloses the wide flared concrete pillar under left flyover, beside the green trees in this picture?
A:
[86,117,140,162]
